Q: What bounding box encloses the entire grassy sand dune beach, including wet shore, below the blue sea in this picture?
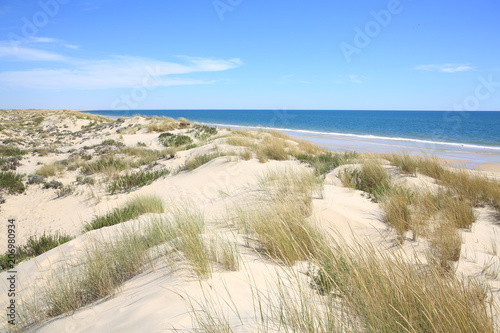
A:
[0,110,500,332]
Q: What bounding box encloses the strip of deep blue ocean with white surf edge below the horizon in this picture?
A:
[89,110,500,149]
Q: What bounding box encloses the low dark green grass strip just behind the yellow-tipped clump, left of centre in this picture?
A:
[106,169,170,194]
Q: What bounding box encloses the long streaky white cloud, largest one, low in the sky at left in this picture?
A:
[0,56,242,90]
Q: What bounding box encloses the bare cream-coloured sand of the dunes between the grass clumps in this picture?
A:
[0,111,500,332]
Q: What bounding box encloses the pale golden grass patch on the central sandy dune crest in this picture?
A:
[235,170,323,265]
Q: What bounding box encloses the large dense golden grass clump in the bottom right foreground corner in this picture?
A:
[308,242,494,333]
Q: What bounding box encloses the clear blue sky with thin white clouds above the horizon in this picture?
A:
[0,0,500,111]
